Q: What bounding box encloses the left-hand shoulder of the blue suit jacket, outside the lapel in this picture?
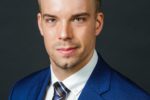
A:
[9,67,50,100]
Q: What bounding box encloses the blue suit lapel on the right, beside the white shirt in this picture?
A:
[79,56,111,100]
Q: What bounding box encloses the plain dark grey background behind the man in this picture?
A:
[0,0,150,100]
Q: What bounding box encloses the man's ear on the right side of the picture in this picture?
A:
[96,12,104,36]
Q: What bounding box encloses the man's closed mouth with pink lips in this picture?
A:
[56,47,77,56]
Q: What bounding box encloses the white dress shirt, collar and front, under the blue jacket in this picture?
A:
[45,50,98,100]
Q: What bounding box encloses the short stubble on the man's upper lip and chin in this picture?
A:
[49,41,83,70]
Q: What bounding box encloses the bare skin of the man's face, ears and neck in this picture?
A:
[37,0,103,81]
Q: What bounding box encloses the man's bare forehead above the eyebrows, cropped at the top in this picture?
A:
[39,0,95,13]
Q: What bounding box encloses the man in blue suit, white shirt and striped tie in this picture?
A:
[9,0,150,100]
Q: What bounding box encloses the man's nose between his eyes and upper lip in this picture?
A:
[58,22,72,40]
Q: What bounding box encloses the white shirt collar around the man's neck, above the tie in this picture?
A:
[51,50,98,95]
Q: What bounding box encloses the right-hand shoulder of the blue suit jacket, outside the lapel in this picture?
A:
[105,68,150,100]
